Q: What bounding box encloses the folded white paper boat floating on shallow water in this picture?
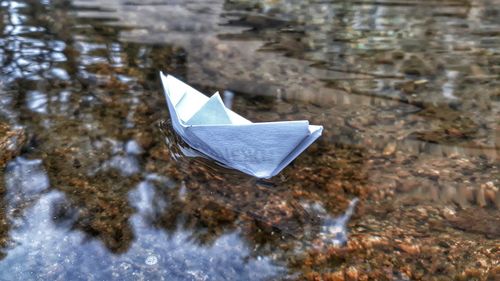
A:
[160,73,323,178]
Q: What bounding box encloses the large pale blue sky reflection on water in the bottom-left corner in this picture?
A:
[0,188,282,280]
